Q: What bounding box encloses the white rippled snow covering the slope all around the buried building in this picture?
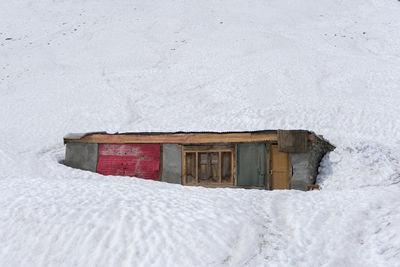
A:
[0,0,400,266]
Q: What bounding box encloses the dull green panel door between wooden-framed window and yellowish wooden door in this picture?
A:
[237,143,267,186]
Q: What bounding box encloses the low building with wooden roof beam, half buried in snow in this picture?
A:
[64,130,335,190]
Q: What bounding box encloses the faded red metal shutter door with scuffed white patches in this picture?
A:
[97,144,160,181]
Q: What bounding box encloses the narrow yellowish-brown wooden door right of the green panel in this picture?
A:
[270,145,290,190]
